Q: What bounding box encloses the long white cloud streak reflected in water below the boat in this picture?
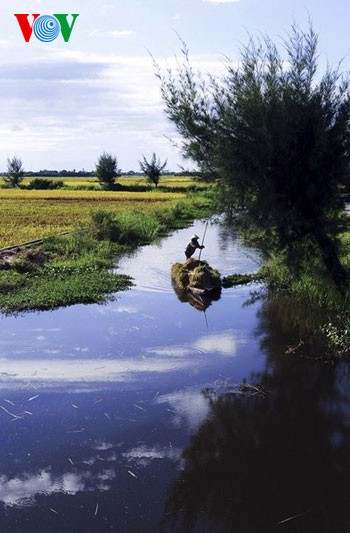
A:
[0,330,242,390]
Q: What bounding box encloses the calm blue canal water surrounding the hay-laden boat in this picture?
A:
[0,218,350,533]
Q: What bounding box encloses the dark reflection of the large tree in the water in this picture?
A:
[163,301,350,533]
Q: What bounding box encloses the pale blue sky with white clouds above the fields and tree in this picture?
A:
[0,0,350,172]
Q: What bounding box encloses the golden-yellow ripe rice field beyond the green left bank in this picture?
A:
[0,187,185,248]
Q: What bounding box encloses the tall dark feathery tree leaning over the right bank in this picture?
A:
[158,25,350,288]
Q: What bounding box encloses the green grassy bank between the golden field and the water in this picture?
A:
[0,194,210,314]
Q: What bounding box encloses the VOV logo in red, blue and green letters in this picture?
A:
[15,13,79,43]
